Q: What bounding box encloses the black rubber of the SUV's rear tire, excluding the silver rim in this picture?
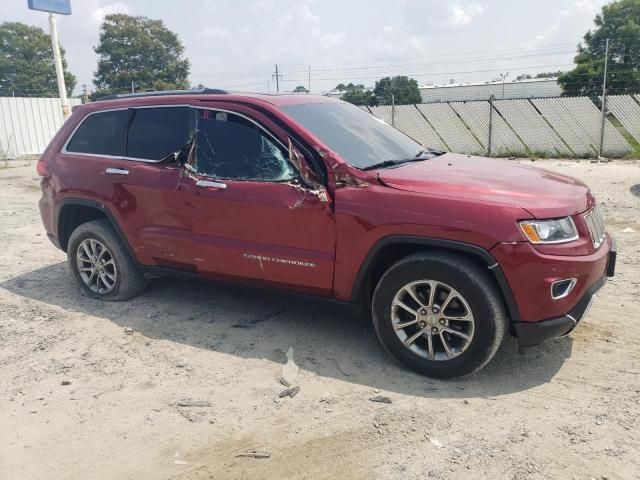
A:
[67,219,147,302]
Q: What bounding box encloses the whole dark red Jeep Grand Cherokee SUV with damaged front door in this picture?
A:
[38,90,615,377]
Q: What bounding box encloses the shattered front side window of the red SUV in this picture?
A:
[195,109,295,182]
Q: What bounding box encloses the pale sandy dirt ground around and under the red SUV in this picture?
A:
[0,161,640,480]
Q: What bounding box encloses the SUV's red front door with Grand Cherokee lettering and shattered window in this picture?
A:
[182,109,336,295]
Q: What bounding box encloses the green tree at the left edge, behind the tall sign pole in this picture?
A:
[0,22,76,97]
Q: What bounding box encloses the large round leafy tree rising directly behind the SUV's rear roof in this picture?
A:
[93,13,190,96]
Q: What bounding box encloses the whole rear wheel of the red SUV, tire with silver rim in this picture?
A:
[67,219,147,302]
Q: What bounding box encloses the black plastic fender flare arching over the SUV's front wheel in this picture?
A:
[351,235,521,322]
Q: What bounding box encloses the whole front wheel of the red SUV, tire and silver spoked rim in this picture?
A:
[372,252,508,378]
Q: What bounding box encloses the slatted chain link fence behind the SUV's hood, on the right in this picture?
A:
[364,95,640,158]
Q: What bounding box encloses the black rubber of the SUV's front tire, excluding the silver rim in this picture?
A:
[372,251,508,378]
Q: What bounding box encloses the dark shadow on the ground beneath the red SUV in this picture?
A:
[0,262,572,399]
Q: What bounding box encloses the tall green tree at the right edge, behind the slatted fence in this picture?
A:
[558,0,640,97]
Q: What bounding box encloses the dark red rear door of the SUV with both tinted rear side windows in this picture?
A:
[65,106,194,270]
